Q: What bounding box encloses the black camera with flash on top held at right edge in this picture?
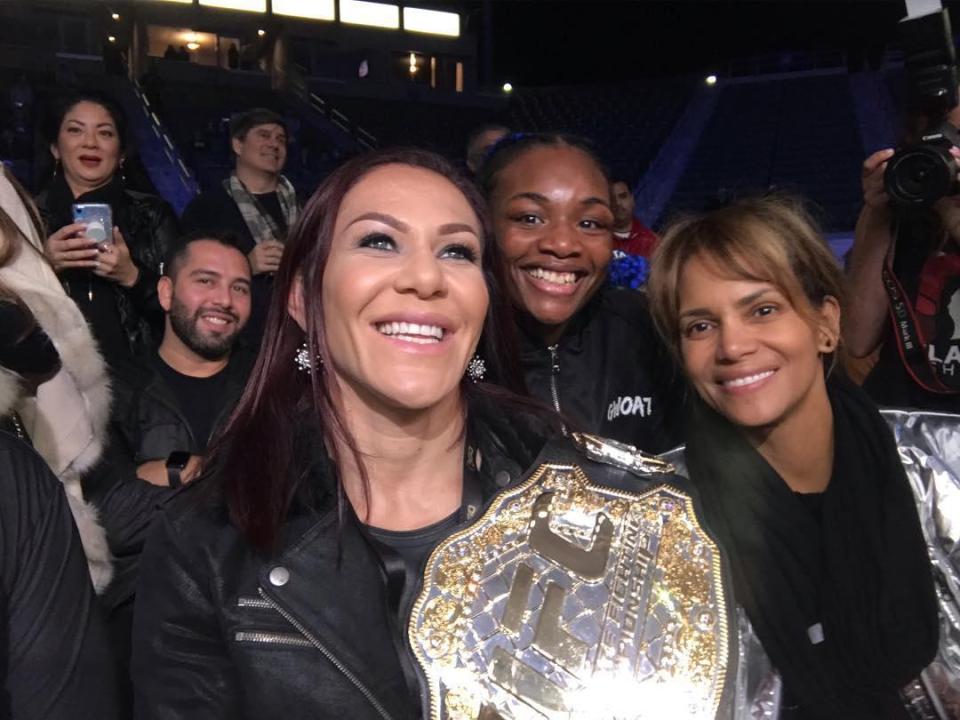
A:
[883,9,960,207]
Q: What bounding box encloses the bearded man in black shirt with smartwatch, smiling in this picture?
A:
[113,233,251,487]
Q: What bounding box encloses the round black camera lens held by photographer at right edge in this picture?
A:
[883,145,957,205]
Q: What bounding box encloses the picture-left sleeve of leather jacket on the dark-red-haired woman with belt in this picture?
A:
[130,496,242,720]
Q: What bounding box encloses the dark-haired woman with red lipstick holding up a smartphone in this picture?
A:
[37,92,177,364]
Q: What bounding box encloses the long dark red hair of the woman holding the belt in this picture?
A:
[204,148,527,549]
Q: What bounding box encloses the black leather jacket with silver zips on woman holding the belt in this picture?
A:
[131,402,684,720]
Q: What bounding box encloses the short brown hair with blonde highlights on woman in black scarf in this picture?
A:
[647,195,844,359]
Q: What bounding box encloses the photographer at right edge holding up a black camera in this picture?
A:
[845,7,960,412]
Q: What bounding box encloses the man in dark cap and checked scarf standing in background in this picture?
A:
[181,108,300,347]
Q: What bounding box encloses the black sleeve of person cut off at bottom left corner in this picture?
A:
[0,433,118,720]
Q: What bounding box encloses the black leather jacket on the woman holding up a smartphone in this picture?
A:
[36,181,179,363]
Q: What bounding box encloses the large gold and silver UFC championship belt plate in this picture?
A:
[408,434,731,720]
